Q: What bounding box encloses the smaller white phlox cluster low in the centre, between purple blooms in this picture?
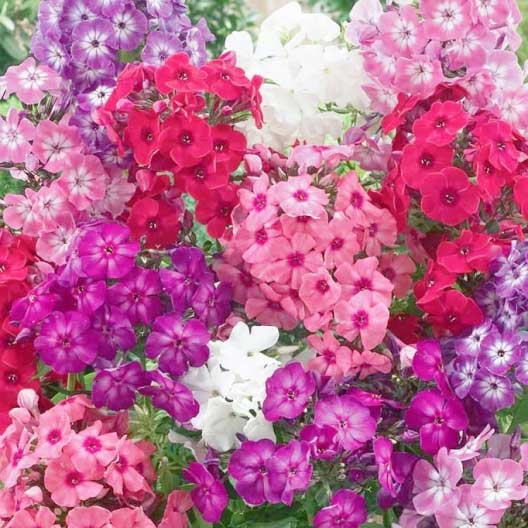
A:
[182,323,281,451]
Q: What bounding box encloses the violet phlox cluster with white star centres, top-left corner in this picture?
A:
[31,0,214,156]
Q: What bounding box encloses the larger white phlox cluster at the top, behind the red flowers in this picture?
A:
[226,2,368,151]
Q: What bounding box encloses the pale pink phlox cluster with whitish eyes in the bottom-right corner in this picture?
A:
[400,426,528,528]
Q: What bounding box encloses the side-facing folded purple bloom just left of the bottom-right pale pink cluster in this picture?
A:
[373,437,418,497]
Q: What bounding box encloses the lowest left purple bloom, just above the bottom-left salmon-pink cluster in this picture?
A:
[92,361,148,411]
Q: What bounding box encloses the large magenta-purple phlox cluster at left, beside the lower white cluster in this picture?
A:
[11,222,231,423]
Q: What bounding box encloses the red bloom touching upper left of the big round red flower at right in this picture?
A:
[400,141,453,189]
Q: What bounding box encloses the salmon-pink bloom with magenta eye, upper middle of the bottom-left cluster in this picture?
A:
[64,419,118,472]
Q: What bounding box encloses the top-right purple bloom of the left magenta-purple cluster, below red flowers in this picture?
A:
[160,247,214,312]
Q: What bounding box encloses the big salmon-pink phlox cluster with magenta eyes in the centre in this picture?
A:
[216,147,414,376]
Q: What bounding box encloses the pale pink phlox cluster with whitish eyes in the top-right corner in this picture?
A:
[346,0,528,130]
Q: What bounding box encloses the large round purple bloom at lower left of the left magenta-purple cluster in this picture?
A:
[35,311,97,374]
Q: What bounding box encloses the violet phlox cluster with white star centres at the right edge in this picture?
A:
[446,243,528,412]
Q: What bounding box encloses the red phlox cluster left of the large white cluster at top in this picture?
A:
[98,53,262,238]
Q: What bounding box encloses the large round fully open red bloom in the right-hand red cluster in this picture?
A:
[420,167,480,226]
